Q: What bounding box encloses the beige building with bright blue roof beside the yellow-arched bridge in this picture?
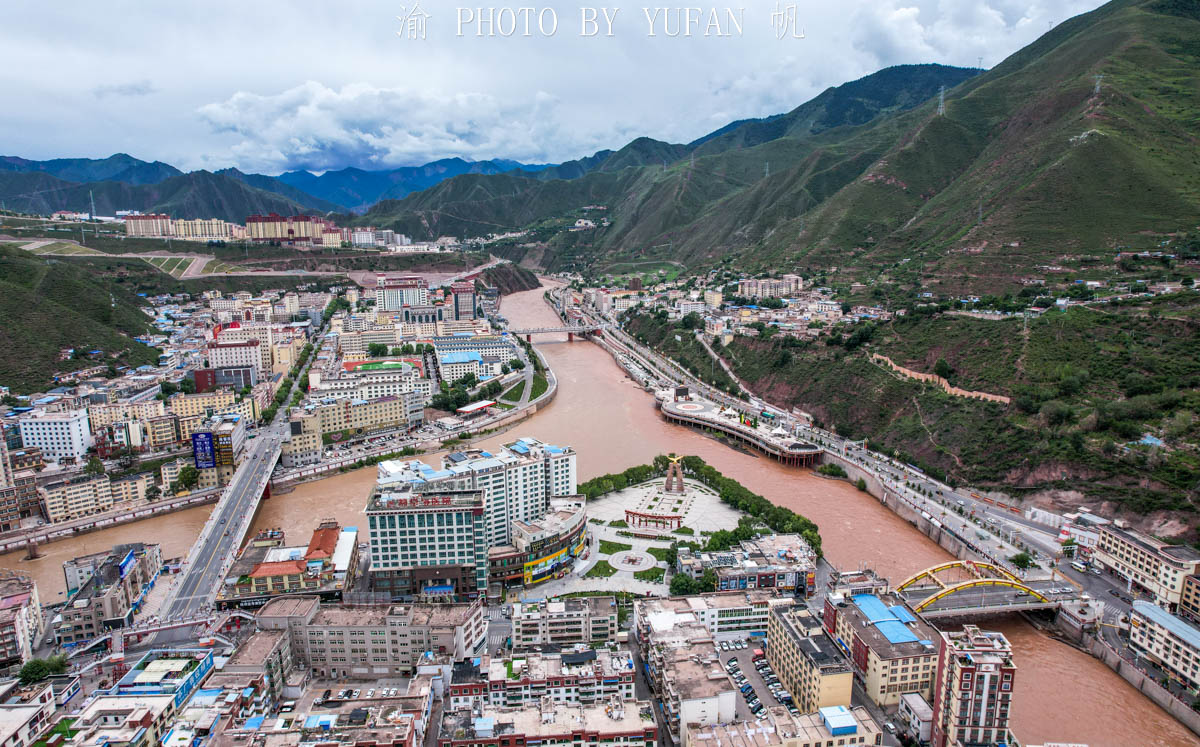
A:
[824,591,941,707]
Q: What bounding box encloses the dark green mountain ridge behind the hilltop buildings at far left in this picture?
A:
[0,172,310,223]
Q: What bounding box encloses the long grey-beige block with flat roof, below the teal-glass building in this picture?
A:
[256,596,487,679]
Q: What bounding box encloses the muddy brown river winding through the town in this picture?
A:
[7,282,1200,747]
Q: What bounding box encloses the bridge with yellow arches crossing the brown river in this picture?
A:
[895,560,1080,617]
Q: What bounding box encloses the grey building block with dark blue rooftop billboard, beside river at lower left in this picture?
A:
[50,542,162,646]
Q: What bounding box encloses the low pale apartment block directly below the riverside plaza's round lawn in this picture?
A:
[512,597,617,649]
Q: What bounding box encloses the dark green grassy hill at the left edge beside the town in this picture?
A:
[0,244,158,393]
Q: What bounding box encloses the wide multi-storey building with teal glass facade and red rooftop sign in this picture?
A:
[365,485,487,597]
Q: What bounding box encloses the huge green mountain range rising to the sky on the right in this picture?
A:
[357,0,1200,291]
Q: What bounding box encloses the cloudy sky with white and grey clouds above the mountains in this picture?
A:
[0,0,1102,174]
